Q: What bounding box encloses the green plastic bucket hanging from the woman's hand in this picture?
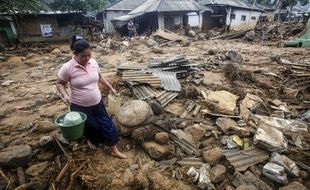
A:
[54,112,87,141]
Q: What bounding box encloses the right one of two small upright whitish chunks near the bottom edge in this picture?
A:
[198,164,215,190]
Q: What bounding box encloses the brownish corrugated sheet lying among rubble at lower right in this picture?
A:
[223,146,269,171]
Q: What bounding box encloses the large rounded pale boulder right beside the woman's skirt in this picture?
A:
[117,100,154,127]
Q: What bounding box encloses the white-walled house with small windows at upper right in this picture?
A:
[199,0,264,31]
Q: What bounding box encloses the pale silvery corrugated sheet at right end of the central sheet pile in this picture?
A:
[149,69,181,92]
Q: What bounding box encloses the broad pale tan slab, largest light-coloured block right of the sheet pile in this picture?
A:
[201,90,239,115]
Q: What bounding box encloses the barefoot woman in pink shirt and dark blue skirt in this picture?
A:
[57,36,126,158]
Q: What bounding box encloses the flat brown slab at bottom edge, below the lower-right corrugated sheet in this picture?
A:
[232,171,272,190]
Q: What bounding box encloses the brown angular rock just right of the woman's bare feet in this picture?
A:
[143,141,168,160]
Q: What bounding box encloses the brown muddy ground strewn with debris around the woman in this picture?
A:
[0,39,310,189]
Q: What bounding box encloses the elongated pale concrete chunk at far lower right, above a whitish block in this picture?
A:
[270,152,300,177]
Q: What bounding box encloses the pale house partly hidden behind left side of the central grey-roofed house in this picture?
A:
[103,0,146,33]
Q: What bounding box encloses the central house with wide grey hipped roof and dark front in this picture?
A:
[112,0,210,34]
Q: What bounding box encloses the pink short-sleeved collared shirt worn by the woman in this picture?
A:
[58,57,101,107]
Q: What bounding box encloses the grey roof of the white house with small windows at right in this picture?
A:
[199,0,264,12]
